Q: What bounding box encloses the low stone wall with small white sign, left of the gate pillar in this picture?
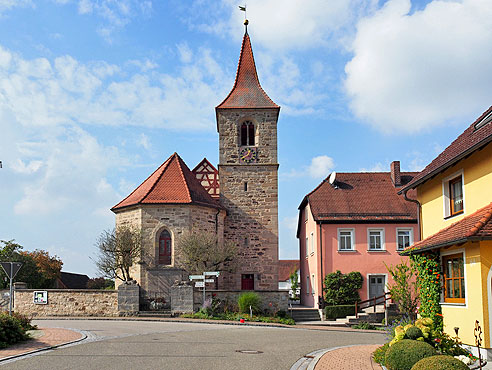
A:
[14,289,118,317]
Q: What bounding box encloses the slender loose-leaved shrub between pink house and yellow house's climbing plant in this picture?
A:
[385,262,419,319]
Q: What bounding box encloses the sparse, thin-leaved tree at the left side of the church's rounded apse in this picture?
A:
[95,226,142,281]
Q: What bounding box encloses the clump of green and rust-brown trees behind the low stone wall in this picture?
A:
[0,240,63,289]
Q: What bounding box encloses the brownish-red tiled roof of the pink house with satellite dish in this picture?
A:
[299,172,417,223]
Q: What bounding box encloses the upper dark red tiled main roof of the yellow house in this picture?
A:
[401,106,492,192]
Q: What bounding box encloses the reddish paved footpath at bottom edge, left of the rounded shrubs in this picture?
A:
[314,344,381,370]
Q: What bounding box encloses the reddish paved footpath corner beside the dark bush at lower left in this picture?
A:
[0,328,84,360]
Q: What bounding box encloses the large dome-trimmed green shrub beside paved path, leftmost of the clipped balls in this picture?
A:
[384,339,437,370]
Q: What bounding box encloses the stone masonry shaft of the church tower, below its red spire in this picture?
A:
[218,109,278,290]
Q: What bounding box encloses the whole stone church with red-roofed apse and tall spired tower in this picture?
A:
[111,28,280,297]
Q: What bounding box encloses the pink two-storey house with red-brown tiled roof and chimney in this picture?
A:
[297,161,420,308]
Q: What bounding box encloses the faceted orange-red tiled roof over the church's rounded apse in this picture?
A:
[111,153,222,212]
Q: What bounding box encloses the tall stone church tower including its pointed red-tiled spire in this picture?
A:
[215,29,280,290]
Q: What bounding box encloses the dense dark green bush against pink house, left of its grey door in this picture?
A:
[323,270,362,305]
